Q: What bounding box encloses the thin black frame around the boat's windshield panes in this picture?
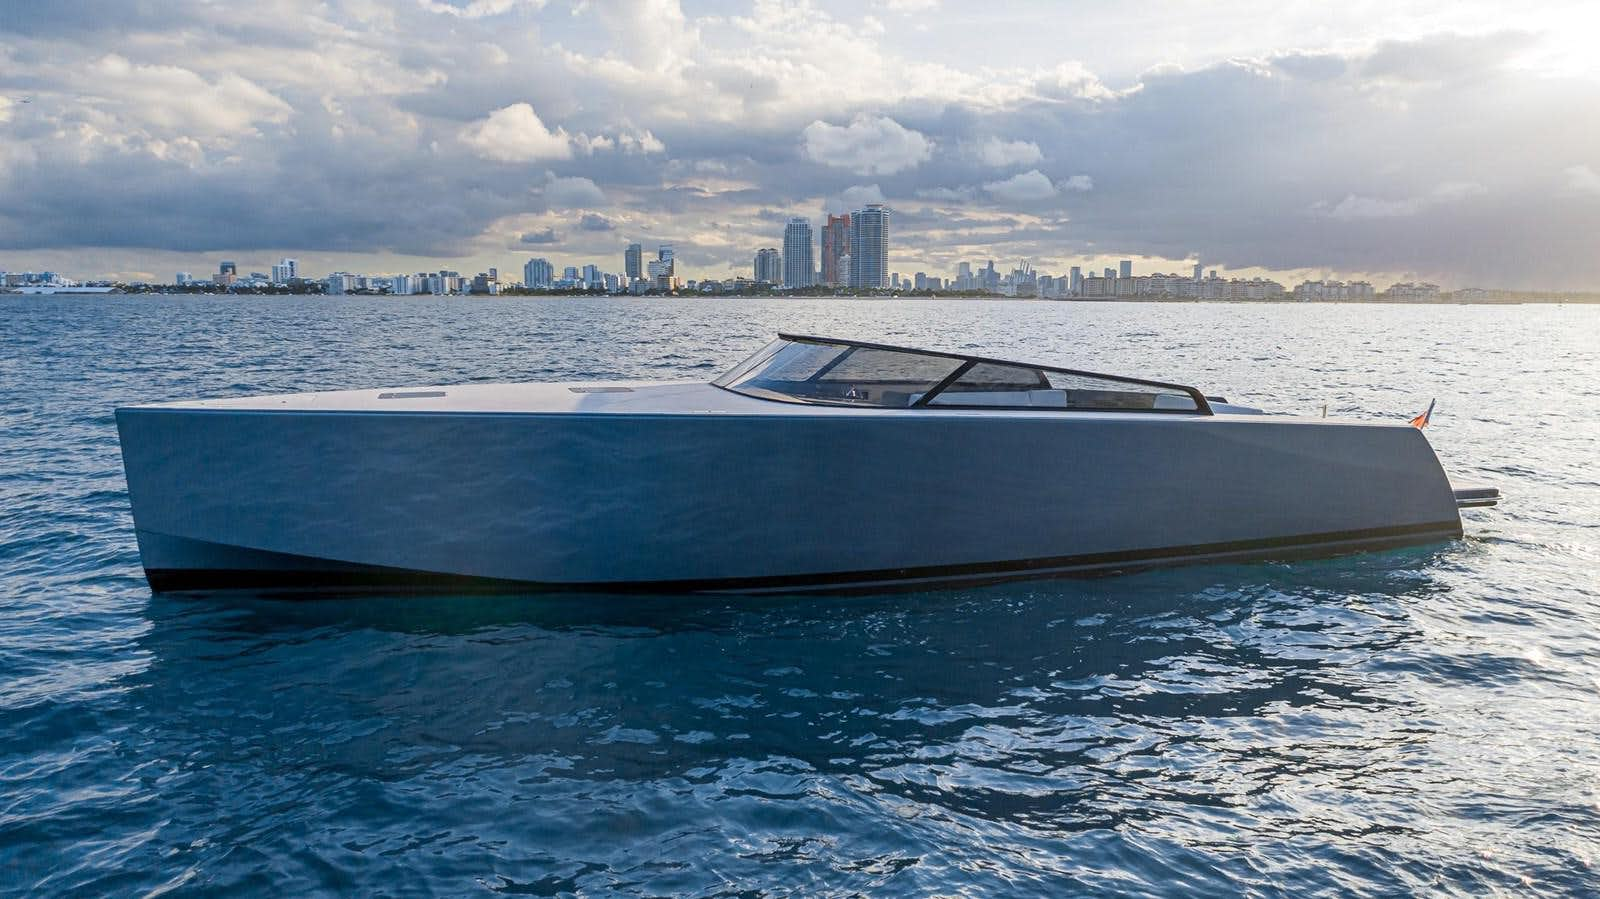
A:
[712,331,1216,416]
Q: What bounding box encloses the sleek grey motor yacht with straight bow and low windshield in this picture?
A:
[117,336,1499,592]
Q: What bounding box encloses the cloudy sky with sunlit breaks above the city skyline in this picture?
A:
[0,0,1600,290]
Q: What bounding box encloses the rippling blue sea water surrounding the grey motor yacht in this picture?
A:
[0,298,1600,896]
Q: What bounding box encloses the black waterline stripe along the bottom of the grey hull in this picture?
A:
[146,521,1461,593]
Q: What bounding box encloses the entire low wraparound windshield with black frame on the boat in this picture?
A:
[714,336,1211,414]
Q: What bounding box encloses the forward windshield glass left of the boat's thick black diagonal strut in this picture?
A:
[715,341,962,408]
